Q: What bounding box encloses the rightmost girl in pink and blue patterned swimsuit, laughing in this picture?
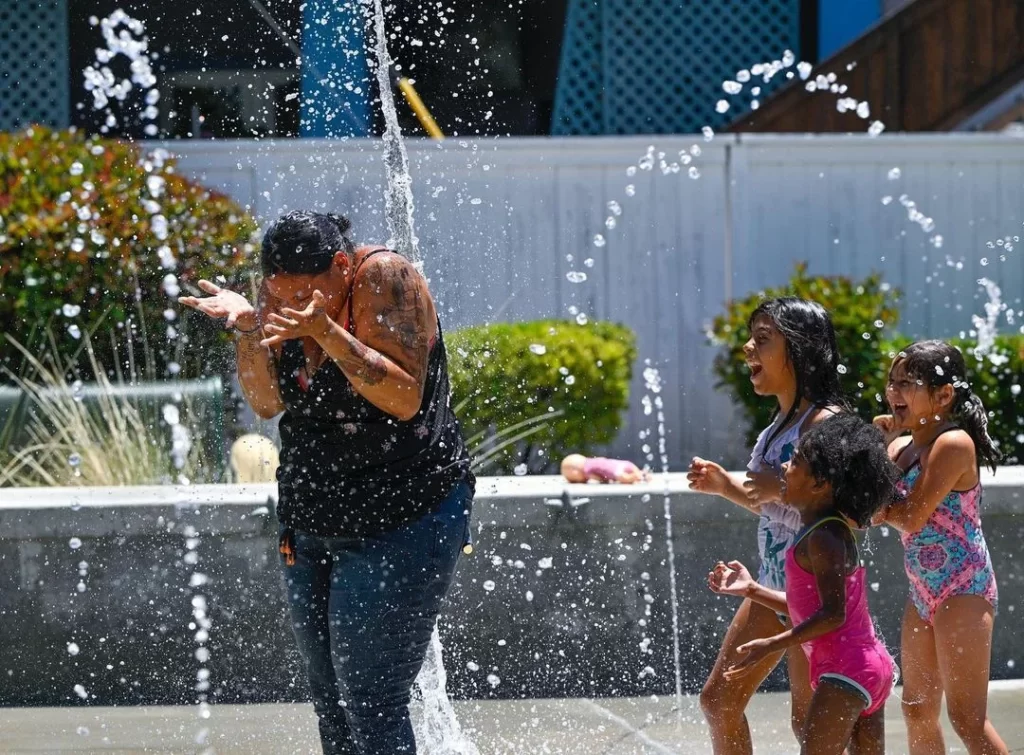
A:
[874,341,1008,755]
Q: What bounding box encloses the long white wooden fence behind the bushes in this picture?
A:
[166,134,1024,468]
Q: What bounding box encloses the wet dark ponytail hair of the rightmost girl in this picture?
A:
[893,341,1002,472]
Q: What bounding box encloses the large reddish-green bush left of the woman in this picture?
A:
[0,126,256,379]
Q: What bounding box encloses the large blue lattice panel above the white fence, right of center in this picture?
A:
[552,0,800,134]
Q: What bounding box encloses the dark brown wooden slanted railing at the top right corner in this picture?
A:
[728,0,1024,132]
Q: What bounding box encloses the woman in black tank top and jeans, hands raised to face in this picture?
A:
[181,212,474,753]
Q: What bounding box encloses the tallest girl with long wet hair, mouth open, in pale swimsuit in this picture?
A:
[688,297,846,755]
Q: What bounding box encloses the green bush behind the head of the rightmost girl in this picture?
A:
[864,336,1024,464]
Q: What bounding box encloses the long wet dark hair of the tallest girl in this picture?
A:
[746,296,850,453]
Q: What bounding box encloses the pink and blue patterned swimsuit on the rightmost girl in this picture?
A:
[897,450,998,624]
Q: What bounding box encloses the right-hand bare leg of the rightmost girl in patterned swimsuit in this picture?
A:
[934,595,1009,755]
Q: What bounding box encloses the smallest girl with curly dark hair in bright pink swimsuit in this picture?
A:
[708,414,899,755]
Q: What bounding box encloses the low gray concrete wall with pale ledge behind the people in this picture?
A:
[0,468,1024,706]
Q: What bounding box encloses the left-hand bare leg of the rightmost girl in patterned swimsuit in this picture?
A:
[901,600,946,755]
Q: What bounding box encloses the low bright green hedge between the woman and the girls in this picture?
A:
[449,320,637,473]
